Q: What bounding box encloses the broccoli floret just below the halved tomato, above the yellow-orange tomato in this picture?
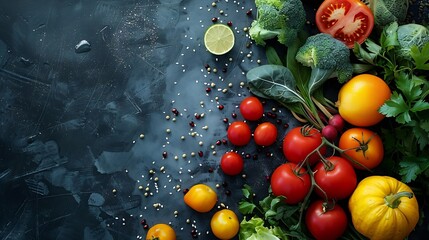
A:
[296,33,353,83]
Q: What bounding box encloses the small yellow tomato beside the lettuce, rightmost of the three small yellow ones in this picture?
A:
[210,209,240,240]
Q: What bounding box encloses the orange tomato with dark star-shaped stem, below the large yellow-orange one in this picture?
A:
[338,128,384,169]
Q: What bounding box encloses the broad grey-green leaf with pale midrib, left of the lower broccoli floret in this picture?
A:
[246,64,305,104]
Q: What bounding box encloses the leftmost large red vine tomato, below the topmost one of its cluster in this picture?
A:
[271,162,311,204]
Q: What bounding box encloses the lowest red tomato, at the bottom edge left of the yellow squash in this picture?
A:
[305,200,348,240]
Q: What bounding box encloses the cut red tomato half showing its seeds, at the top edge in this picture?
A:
[316,0,374,48]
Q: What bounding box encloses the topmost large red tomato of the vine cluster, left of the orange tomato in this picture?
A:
[283,126,326,165]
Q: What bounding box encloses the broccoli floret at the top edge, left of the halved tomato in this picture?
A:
[249,0,306,46]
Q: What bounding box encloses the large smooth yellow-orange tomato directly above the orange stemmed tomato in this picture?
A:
[336,74,391,127]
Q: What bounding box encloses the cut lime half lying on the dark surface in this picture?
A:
[204,23,235,55]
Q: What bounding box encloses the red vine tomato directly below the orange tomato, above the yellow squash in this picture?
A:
[313,156,357,200]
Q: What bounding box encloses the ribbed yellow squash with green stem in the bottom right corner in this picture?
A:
[349,176,419,240]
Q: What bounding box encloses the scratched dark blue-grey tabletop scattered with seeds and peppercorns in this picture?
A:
[0,0,426,240]
